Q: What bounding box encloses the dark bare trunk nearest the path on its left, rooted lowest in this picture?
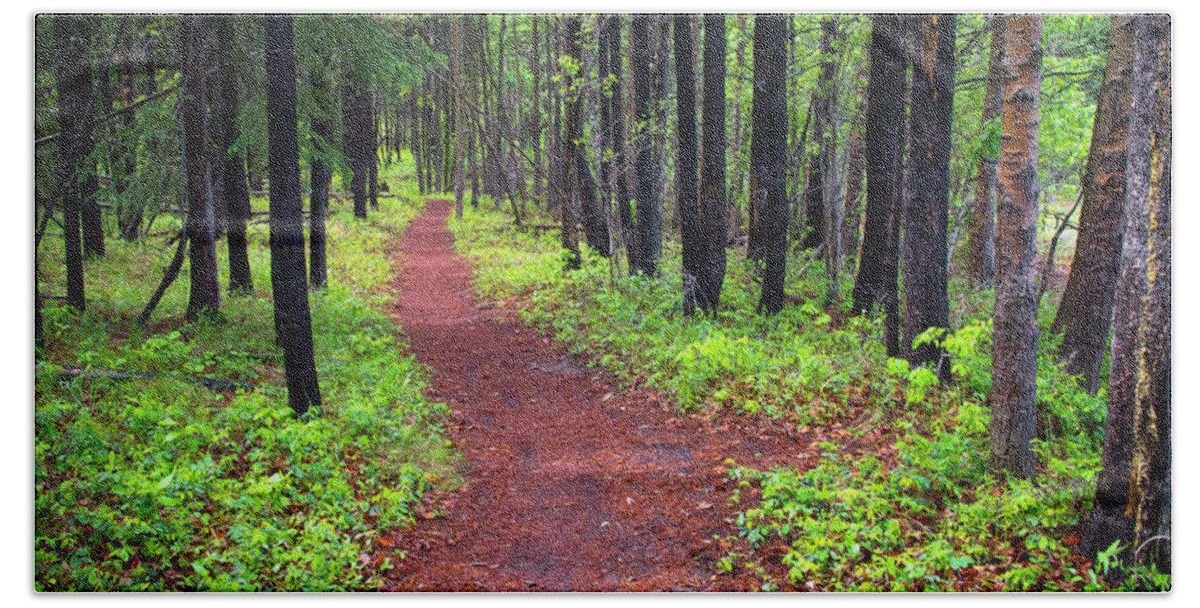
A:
[263,14,320,416]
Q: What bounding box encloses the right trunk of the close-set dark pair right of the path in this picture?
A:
[697,13,727,312]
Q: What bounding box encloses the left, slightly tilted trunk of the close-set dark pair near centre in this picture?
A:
[673,13,704,314]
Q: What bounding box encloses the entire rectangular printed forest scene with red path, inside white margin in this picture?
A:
[34,13,1172,591]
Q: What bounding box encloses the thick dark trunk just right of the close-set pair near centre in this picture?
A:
[750,14,788,314]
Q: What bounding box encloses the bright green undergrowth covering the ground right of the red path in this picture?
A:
[449,206,1152,591]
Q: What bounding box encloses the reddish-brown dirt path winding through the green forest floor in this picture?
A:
[384,200,804,591]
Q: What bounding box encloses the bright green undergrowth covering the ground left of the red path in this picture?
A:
[35,153,460,591]
